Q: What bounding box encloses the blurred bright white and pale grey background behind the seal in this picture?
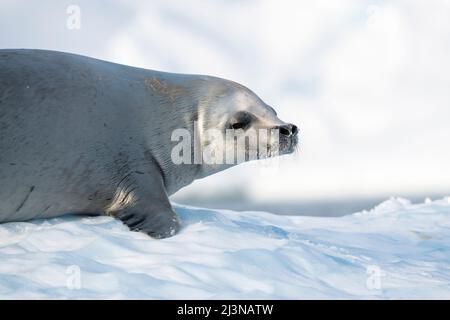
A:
[0,0,450,201]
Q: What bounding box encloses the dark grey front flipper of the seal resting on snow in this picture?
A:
[107,171,180,239]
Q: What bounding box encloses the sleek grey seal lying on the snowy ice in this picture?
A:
[0,49,298,238]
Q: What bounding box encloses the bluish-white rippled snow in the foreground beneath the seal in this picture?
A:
[0,198,450,299]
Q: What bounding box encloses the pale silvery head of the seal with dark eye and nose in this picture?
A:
[198,79,298,164]
